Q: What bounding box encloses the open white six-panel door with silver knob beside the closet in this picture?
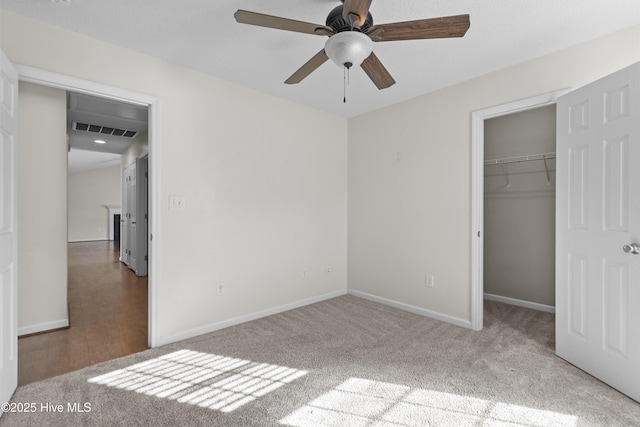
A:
[556,63,640,401]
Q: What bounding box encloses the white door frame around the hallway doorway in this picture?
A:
[13,64,160,348]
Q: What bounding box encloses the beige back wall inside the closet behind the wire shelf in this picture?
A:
[483,105,556,307]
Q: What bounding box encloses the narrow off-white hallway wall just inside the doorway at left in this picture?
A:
[18,82,69,335]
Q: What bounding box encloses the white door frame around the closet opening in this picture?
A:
[469,89,571,331]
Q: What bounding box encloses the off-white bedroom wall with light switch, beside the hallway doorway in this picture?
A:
[0,10,347,342]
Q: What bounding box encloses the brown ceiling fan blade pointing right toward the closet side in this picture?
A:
[368,15,470,42]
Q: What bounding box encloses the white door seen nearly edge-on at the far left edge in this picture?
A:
[0,51,18,404]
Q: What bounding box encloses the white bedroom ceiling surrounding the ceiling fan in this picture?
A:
[0,0,640,117]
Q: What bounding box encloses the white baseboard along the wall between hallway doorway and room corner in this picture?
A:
[156,289,347,347]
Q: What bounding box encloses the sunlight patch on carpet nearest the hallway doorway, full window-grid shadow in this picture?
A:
[88,350,307,412]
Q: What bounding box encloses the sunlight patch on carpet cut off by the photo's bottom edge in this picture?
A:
[280,378,578,427]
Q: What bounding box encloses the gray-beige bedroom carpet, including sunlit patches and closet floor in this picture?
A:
[0,296,640,427]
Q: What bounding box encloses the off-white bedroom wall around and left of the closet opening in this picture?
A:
[348,26,640,324]
